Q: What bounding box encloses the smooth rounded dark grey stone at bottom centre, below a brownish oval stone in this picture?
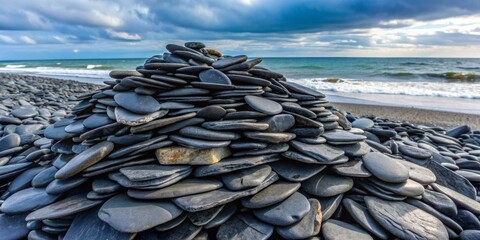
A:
[253,192,310,226]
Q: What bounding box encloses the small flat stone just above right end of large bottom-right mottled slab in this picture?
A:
[422,188,458,217]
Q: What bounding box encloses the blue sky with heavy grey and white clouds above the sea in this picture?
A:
[0,0,480,60]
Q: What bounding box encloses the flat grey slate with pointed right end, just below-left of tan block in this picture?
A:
[120,164,191,181]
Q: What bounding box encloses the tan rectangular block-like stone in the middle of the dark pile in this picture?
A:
[155,147,231,165]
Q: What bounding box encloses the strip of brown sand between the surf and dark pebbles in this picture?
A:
[332,103,480,130]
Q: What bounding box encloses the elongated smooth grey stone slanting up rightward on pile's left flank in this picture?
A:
[55,141,114,179]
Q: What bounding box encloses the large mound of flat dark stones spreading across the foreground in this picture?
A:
[0,42,480,240]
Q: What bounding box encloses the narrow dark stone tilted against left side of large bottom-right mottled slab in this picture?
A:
[342,198,389,239]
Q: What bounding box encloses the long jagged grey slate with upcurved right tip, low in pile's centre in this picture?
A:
[173,172,278,212]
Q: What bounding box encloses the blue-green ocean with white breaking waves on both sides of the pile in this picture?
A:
[0,58,480,99]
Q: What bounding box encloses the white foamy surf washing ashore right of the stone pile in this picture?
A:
[289,78,480,99]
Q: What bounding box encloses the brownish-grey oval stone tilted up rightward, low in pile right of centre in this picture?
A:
[242,181,300,208]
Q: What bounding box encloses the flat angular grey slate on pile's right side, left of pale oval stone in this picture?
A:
[290,140,345,164]
